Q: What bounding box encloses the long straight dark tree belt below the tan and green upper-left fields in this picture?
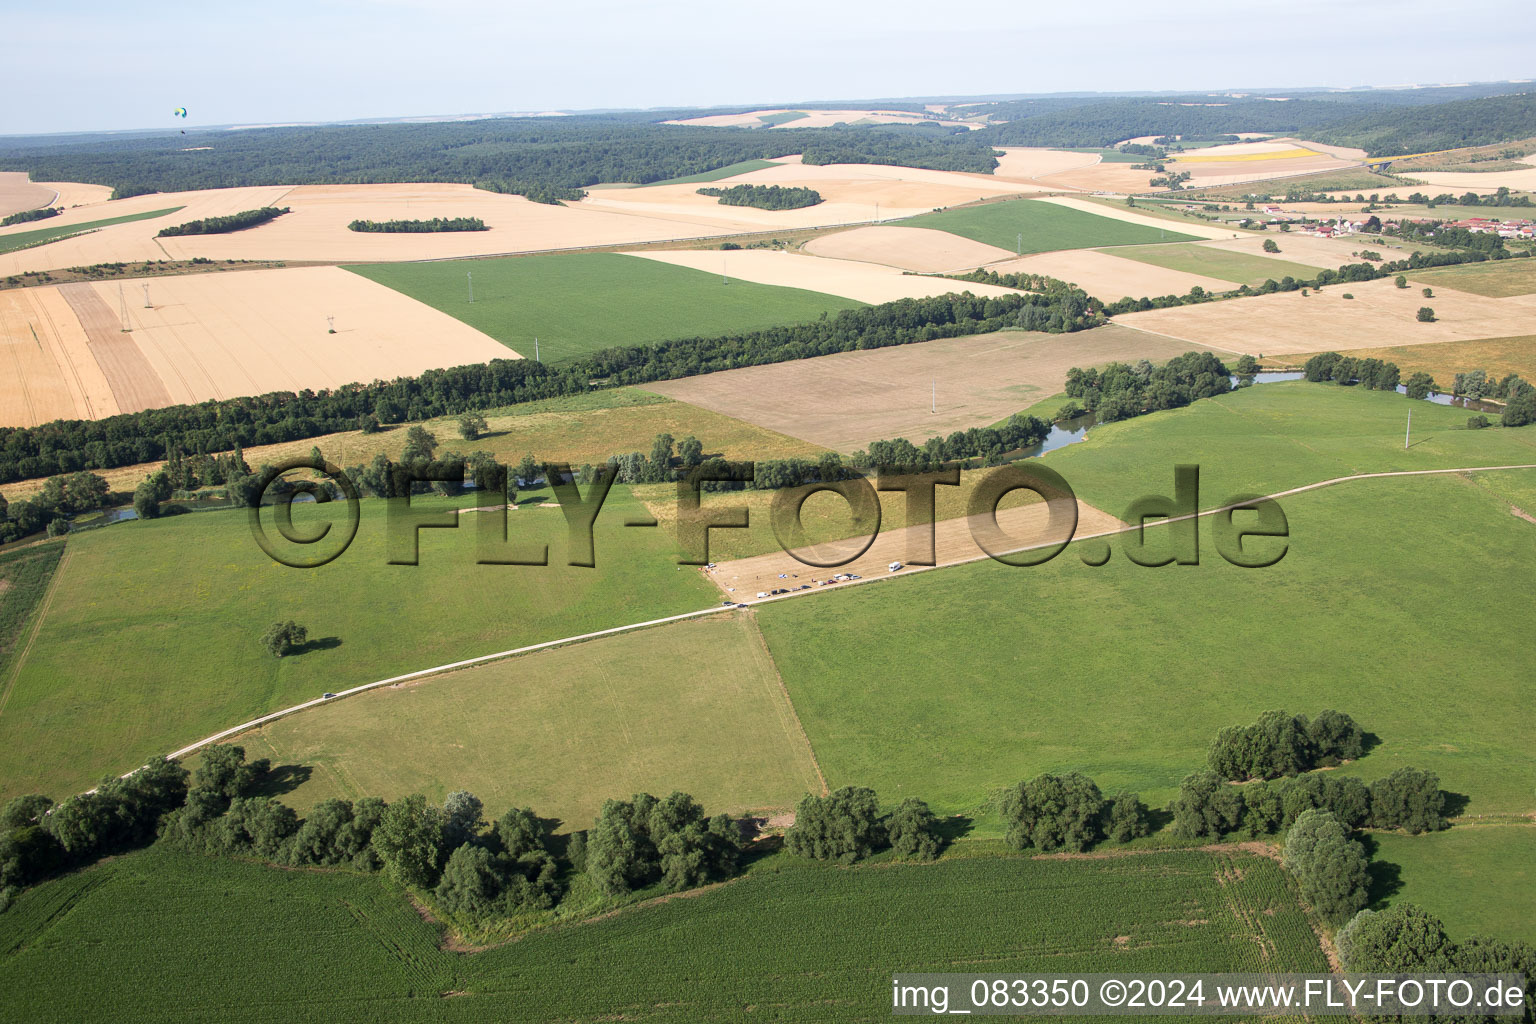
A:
[0,293,1075,484]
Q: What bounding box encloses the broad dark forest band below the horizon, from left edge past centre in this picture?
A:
[0,115,997,196]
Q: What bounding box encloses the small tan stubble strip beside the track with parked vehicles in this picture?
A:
[705,494,1124,603]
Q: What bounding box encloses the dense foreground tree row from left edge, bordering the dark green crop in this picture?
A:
[0,745,742,923]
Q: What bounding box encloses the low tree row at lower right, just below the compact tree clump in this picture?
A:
[1170,768,1447,840]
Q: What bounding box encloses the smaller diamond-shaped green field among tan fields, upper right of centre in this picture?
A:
[899,200,1193,255]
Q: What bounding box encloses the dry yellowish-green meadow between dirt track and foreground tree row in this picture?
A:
[240,614,822,829]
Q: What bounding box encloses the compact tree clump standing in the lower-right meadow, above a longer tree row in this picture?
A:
[1206,709,1366,781]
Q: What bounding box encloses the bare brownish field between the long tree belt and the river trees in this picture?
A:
[645,323,1204,453]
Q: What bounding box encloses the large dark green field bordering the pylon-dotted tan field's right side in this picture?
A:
[347,253,863,362]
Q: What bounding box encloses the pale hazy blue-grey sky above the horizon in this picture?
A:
[0,0,1536,134]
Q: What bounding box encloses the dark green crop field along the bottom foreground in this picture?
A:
[0,847,1326,1024]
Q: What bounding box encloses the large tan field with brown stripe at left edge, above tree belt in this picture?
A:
[0,267,516,427]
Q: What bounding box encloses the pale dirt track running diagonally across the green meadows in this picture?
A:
[141,462,1536,779]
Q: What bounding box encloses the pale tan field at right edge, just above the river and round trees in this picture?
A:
[1115,278,1536,356]
